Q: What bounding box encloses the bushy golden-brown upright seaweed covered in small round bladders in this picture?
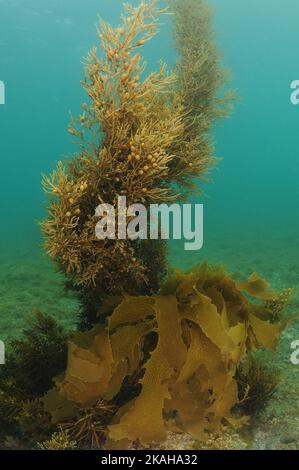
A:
[42,0,233,294]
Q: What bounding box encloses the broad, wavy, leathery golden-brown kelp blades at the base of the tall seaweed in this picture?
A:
[43,265,283,449]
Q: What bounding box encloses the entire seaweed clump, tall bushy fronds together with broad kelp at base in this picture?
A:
[0,0,290,450]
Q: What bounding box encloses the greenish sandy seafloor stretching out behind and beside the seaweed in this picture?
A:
[0,235,299,449]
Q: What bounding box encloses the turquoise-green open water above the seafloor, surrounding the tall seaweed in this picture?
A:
[0,0,299,252]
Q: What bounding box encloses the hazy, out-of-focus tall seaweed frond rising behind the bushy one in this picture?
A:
[169,0,235,189]
